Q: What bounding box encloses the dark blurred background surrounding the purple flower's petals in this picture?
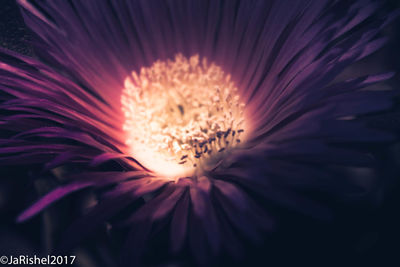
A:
[0,0,400,267]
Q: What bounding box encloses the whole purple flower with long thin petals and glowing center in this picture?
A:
[0,0,394,264]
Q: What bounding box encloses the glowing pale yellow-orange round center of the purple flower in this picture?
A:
[121,54,244,178]
